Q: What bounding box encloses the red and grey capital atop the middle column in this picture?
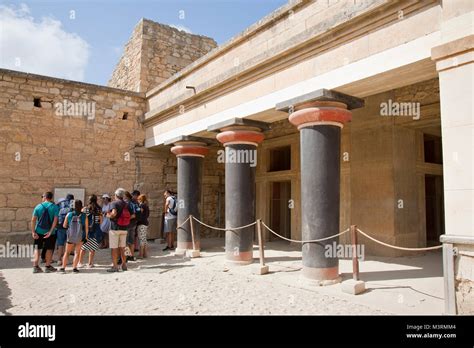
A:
[207,118,270,146]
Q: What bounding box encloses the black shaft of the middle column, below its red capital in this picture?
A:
[225,144,257,263]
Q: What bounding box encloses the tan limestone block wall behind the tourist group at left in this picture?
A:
[0,70,168,242]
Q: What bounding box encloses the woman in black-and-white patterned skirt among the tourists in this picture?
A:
[78,195,102,268]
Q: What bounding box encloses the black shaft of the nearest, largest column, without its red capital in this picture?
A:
[300,125,341,278]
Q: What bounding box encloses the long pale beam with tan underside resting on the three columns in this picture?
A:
[145,31,441,148]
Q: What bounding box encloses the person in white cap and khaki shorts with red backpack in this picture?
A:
[107,188,133,272]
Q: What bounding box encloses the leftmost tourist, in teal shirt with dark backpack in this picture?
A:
[31,192,59,273]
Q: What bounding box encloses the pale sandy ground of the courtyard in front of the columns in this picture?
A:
[0,239,443,315]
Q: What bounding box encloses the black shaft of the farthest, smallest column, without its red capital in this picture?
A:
[177,156,203,250]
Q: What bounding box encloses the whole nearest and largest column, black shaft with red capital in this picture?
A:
[277,90,363,285]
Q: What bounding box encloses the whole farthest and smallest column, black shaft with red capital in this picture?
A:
[165,136,209,254]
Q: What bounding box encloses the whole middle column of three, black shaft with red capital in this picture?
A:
[208,118,268,264]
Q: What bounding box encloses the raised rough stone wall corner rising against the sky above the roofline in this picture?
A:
[108,19,217,92]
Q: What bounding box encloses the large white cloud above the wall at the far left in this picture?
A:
[0,4,89,81]
